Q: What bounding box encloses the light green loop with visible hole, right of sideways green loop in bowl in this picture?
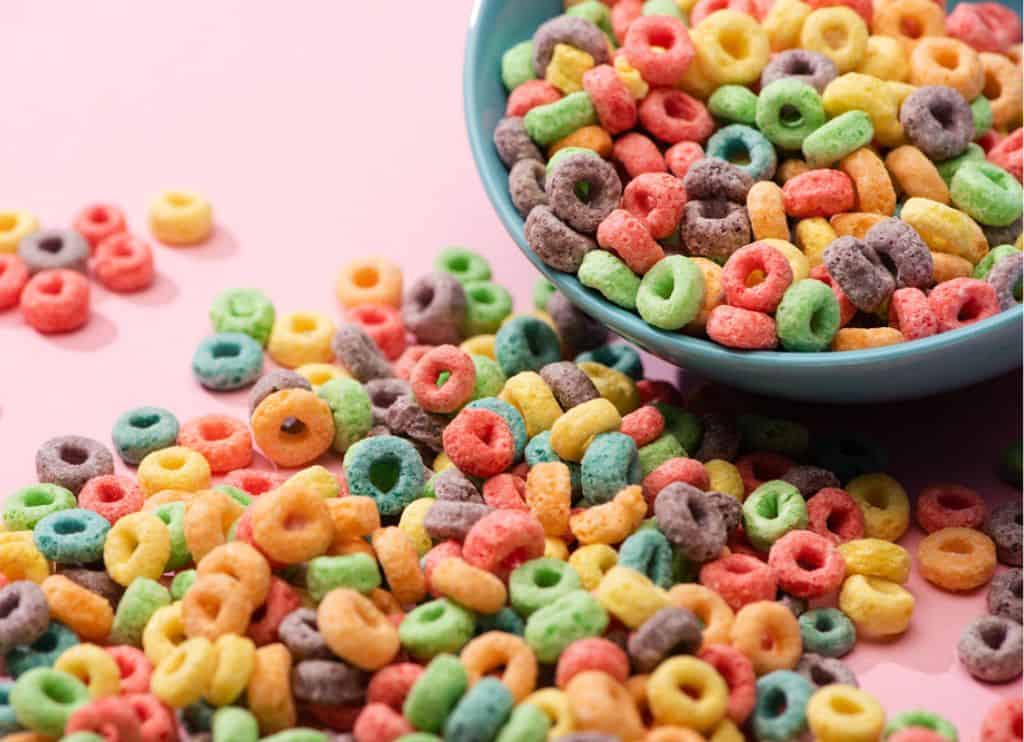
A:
[638,252,704,330]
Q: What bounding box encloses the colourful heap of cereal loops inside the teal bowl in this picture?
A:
[494,0,1024,352]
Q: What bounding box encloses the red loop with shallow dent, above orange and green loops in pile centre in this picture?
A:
[462,510,544,579]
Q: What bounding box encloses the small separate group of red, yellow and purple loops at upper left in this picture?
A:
[0,191,213,333]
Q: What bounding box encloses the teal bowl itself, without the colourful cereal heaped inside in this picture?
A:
[463,0,1024,402]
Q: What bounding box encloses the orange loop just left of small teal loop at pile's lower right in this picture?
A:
[730,601,803,675]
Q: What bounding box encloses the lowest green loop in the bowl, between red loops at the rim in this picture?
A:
[775,278,841,353]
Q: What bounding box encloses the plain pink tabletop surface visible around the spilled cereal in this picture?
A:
[0,0,1021,740]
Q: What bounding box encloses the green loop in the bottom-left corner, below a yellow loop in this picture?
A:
[10,667,89,737]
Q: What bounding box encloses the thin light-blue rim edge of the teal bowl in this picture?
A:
[462,0,1024,370]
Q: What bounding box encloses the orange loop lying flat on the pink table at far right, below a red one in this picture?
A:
[917,528,995,592]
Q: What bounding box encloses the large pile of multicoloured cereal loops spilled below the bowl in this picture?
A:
[0,250,1022,742]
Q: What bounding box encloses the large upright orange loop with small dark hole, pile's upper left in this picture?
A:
[250,389,334,467]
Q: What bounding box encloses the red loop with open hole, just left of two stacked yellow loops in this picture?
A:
[768,530,846,600]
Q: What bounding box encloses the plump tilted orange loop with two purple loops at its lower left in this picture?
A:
[316,587,399,670]
